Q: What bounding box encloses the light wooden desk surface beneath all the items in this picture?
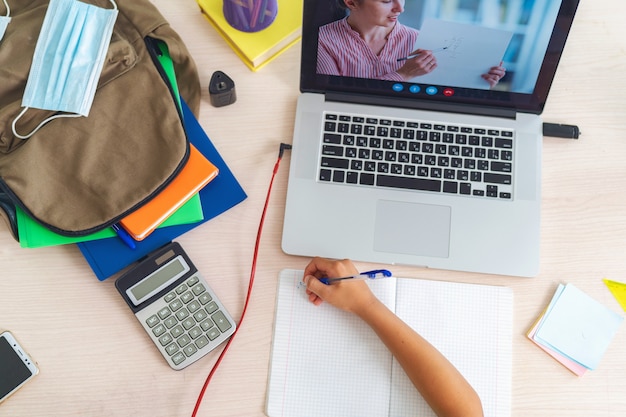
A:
[0,0,626,417]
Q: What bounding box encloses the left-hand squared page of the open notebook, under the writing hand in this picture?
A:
[267,270,395,417]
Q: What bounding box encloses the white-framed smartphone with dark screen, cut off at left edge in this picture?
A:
[0,331,39,403]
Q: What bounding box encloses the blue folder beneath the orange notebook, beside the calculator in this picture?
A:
[78,101,247,281]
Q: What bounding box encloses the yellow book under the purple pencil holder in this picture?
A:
[197,0,303,71]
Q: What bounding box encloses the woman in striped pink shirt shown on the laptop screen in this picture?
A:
[317,0,505,87]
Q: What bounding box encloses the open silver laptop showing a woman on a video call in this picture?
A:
[282,0,578,277]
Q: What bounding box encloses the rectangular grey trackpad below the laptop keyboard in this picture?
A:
[374,200,451,258]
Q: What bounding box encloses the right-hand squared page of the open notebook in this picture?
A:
[389,279,513,417]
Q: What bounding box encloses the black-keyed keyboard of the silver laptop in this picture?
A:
[318,113,514,200]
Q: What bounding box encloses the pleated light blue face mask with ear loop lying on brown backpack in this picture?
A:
[12,0,118,139]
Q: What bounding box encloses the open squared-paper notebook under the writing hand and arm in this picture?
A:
[266,270,513,417]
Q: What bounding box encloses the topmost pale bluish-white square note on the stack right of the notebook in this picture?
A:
[535,284,623,369]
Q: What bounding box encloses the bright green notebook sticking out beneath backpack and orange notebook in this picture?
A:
[16,194,204,248]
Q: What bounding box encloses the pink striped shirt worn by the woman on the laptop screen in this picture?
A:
[317,18,418,81]
